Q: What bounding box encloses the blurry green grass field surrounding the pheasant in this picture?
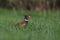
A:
[0,9,60,40]
